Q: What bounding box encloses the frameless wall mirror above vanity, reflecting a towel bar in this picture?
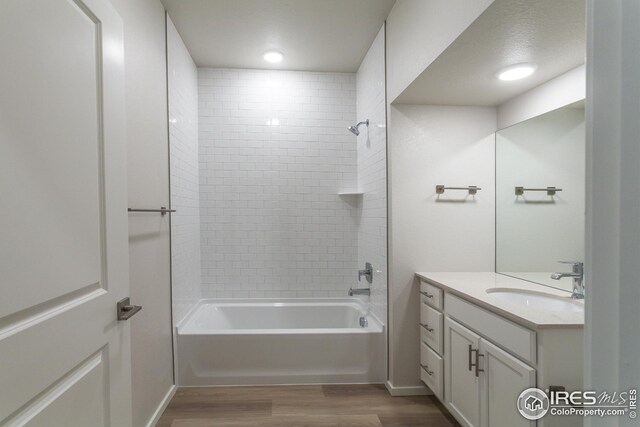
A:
[496,101,586,291]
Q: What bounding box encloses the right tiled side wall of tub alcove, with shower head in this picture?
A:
[356,26,387,324]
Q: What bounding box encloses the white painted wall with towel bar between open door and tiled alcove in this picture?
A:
[111,0,173,426]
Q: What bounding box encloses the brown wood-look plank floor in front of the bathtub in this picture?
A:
[157,385,459,427]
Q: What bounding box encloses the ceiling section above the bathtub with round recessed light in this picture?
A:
[162,0,395,72]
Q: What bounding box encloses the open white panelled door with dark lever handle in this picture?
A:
[0,0,131,427]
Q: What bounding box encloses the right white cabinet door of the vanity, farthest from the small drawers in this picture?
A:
[480,340,536,427]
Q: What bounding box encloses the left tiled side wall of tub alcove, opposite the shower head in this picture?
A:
[167,17,202,325]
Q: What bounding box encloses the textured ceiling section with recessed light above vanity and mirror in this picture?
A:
[394,0,586,106]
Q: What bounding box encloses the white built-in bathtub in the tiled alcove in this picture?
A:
[177,298,386,386]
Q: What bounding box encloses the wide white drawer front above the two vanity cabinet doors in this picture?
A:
[446,294,537,365]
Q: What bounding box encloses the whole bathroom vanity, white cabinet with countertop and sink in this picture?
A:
[416,272,584,427]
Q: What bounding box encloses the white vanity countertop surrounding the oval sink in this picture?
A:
[416,272,584,329]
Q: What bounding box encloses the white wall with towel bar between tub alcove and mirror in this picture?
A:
[389,105,496,391]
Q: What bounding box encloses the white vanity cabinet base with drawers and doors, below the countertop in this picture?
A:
[420,273,583,427]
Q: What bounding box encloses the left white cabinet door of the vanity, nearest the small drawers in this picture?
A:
[444,318,480,427]
